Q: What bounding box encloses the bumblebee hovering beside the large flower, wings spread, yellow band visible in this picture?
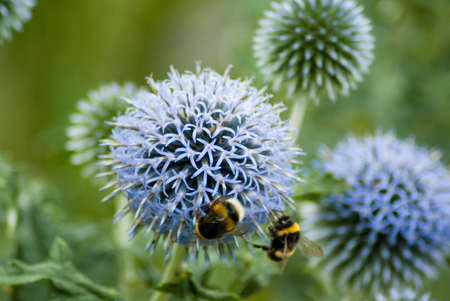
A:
[246,215,323,271]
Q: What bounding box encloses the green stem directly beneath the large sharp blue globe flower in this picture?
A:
[150,244,186,301]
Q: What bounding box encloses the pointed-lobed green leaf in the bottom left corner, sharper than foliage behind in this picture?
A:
[0,238,122,301]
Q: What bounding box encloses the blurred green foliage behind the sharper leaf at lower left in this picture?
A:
[0,171,120,301]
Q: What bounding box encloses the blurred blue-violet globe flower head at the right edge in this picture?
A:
[310,131,450,293]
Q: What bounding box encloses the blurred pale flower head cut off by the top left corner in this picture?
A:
[0,0,34,42]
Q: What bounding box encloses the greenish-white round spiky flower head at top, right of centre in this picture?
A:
[254,0,374,102]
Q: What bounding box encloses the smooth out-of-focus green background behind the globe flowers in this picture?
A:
[0,0,450,300]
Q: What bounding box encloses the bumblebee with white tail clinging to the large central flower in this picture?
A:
[195,197,250,240]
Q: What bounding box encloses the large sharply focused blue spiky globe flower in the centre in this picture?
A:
[104,66,300,258]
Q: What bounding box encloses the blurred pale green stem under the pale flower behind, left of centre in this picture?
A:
[114,196,137,296]
